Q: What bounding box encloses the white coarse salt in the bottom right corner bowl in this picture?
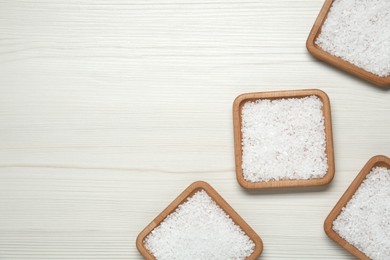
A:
[333,167,390,260]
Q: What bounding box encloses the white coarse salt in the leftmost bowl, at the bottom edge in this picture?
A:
[144,190,255,260]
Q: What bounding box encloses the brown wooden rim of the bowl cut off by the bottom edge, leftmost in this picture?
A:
[136,181,263,259]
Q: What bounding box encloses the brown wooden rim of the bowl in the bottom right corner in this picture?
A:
[324,155,390,260]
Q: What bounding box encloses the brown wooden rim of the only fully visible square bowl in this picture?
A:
[233,89,335,189]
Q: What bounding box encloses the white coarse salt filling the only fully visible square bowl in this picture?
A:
[241,96,328,182]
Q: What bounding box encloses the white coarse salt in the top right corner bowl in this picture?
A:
[316,0,390,77]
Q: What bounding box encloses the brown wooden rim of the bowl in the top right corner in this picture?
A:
[306,0,390,86]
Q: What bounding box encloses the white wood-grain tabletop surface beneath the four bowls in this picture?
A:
[0,0,390,260]
